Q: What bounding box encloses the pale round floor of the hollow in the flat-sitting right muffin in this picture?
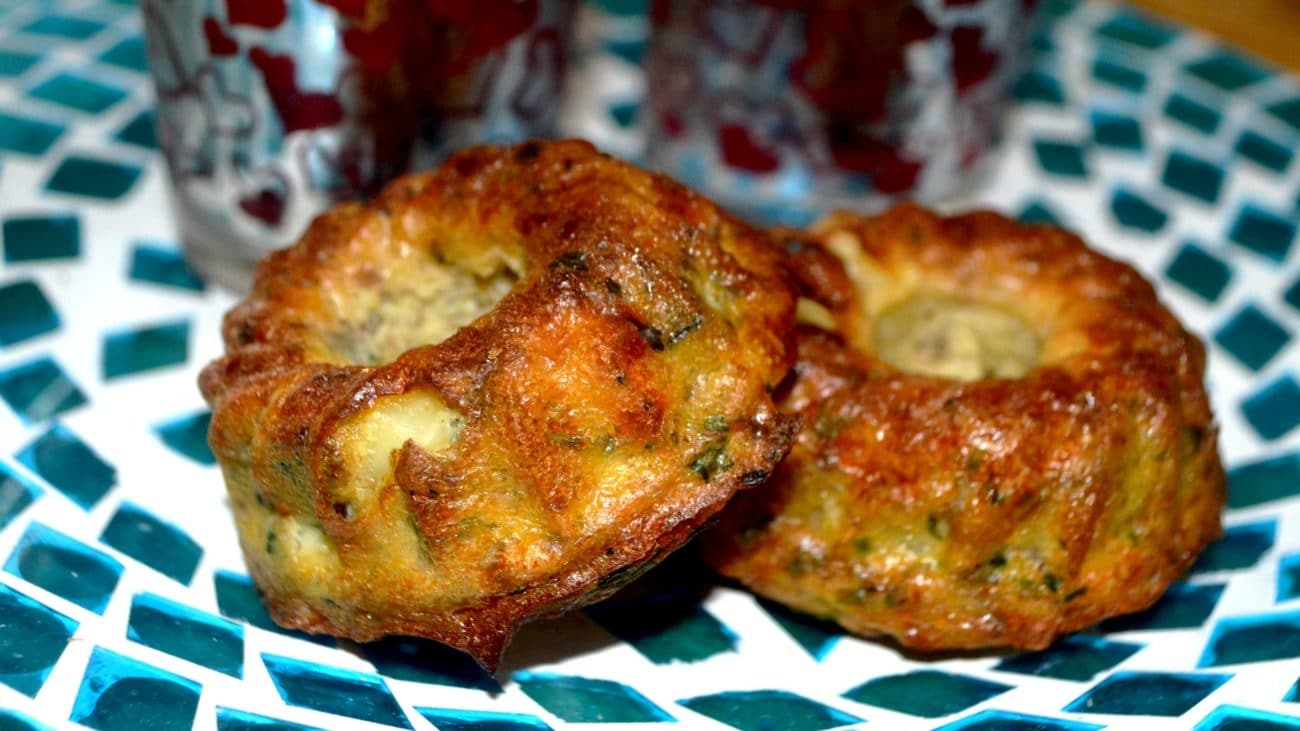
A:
[871,293,1041,381]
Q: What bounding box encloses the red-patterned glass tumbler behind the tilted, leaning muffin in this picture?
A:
[140,0,575,290]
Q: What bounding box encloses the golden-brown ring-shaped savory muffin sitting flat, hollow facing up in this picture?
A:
[706,207,1225,650]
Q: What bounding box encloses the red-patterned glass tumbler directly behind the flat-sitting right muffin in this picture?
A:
[646,0,1034,224]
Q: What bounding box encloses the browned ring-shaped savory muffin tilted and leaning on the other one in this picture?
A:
[200,142,794,667]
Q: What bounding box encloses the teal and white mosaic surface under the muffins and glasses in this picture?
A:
[0,0,1300,731]
